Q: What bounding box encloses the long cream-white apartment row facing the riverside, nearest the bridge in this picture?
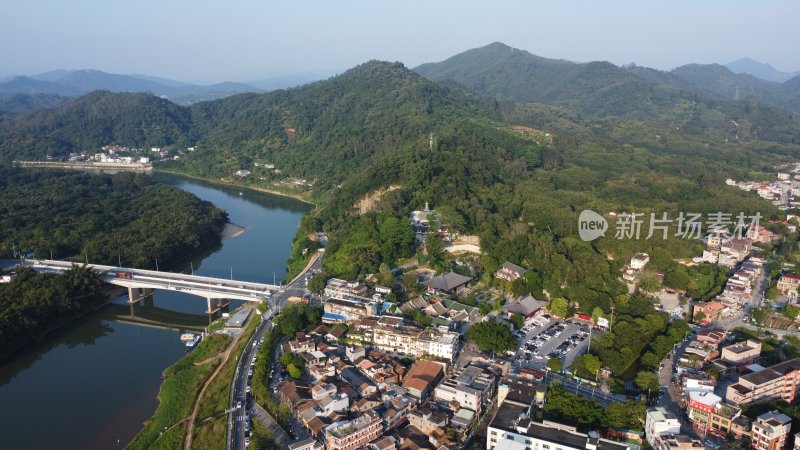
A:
[348,316,460,361]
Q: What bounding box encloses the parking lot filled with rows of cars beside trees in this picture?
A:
[516,316,591,368]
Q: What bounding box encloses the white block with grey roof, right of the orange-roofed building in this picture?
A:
[434,366,497,414]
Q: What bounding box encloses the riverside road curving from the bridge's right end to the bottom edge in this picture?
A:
[227,253,322,450]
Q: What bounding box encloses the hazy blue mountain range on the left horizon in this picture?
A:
[0,70,262,104]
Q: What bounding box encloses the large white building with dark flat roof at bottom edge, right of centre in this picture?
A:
[486,403,629,450]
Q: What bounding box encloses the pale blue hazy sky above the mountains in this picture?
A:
[0,0,800,82]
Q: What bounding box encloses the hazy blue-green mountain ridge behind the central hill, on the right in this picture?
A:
[414,42,800,139]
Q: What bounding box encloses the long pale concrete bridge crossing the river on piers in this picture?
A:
[22,259,281,314]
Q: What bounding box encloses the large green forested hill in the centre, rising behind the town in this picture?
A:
[0,57,798,305]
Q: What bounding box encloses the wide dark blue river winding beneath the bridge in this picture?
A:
[0,172,311,449]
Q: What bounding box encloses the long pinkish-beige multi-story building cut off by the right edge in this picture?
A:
[725,358,800,405]
